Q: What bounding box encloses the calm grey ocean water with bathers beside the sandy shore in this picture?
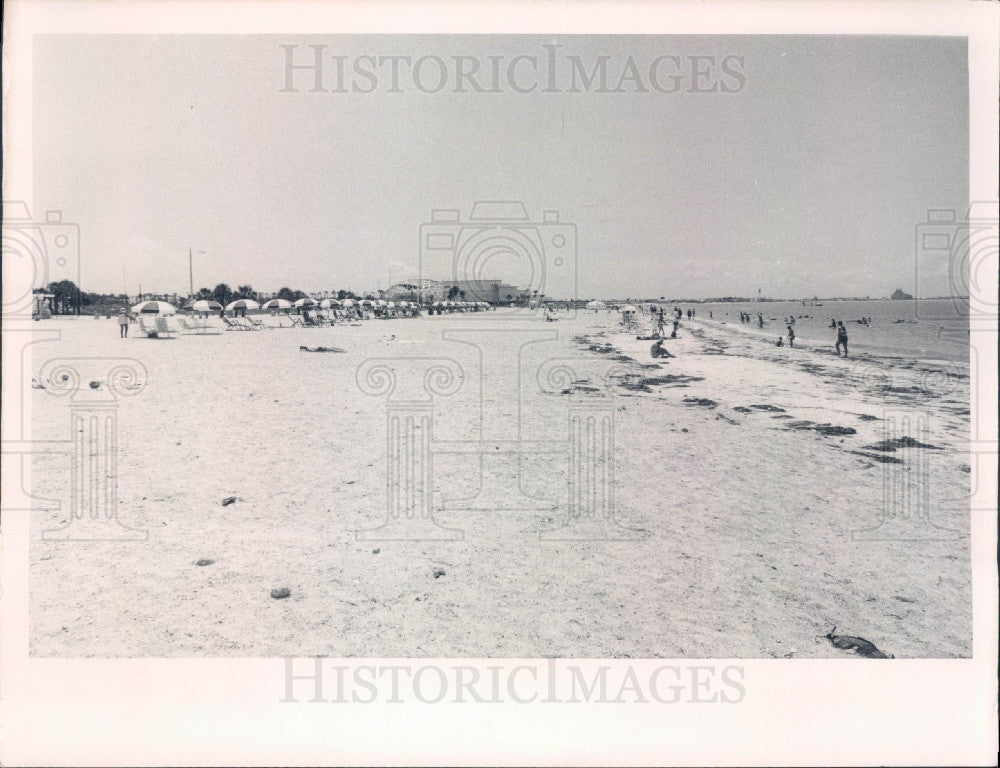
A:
[678,299,969,362]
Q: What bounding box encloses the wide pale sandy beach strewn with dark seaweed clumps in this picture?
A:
[30,312,972,658]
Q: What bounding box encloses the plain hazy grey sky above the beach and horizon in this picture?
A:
[33,35,968,298]
